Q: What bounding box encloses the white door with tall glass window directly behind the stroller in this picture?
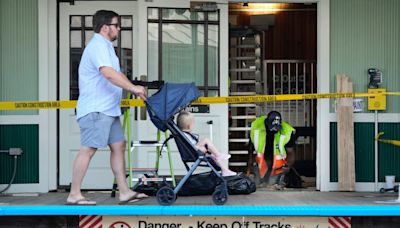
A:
[132,0,228,175]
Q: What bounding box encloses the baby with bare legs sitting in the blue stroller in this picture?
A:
[176,111,237,177]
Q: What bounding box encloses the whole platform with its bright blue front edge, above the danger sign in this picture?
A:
[0,188,400,228]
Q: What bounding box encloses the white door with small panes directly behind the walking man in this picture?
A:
[59,1,137,189]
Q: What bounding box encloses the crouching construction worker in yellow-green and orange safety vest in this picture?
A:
[249,111,295,189]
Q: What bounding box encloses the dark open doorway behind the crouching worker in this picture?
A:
[229,2,317,187]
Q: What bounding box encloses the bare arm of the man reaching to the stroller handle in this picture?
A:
[100,66,147,100]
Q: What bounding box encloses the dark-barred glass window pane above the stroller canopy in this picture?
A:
[147,8,220,96]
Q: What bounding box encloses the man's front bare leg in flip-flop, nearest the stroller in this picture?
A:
[110,141,147,201]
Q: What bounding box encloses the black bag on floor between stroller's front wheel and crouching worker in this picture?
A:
[225,174,256,195]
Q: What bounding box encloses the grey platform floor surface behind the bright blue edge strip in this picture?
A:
[0,188,400,206]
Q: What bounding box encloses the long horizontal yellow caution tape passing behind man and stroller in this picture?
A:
[0,92,400,110]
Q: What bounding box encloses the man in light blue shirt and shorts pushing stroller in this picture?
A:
[67,10,148,205]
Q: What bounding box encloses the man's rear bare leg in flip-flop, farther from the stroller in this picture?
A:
[67,146,96,204]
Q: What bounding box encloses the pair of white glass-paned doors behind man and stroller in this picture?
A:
[59,0,228,189]
